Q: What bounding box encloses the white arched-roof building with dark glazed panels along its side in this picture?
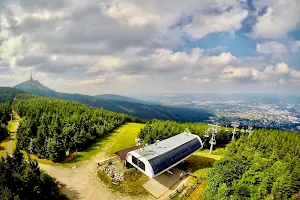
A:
[125,132,203,178]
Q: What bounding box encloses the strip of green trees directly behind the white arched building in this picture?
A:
[138,120,242,148]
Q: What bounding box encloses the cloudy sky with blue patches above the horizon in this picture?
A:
[0,0,300,95]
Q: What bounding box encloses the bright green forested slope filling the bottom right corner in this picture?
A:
[204,129,300,200]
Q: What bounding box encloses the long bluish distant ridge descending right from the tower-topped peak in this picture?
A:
[14,79,212,122]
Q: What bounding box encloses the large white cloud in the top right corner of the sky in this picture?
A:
[252,0,300,39]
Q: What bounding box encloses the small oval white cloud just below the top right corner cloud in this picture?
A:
[256,41,287,54]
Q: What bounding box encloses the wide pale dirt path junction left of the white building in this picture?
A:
[39,153,152,200]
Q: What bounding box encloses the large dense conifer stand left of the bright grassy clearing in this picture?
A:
[13,94,141,162]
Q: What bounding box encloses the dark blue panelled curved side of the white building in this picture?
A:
[149,138,202,174]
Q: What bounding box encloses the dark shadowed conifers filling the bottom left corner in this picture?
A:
[0,150,66,200]
